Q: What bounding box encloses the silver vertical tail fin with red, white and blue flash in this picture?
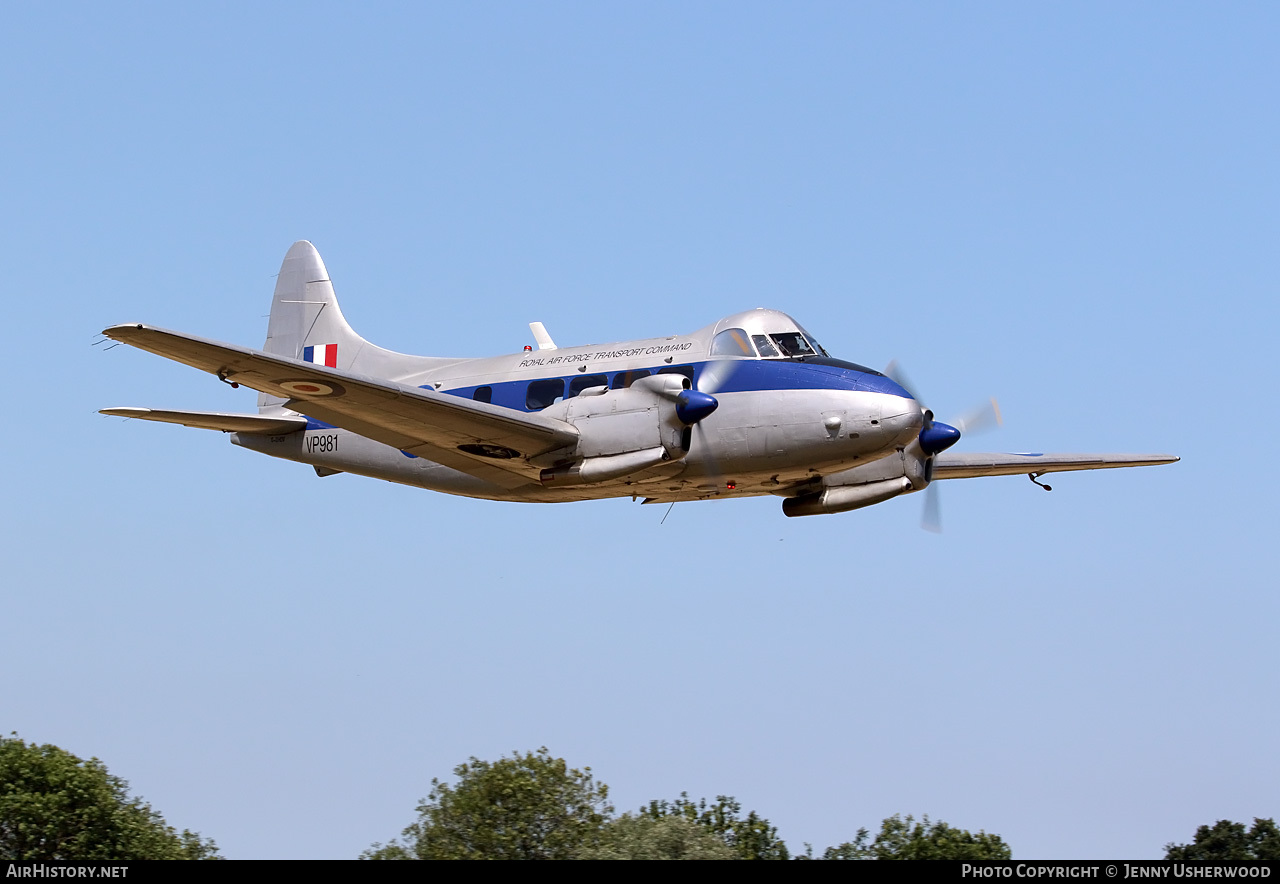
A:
[257,239,454,411]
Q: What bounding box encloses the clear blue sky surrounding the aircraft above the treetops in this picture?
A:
[0,3,1280,858]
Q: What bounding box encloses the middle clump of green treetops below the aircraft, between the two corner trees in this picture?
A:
[361,748,1010,860]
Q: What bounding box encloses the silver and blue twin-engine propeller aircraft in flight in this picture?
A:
[102,242,1178,516]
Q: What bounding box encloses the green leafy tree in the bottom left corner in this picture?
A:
[0,734,221,861]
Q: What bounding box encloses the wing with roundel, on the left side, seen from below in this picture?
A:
[102,324,577,487]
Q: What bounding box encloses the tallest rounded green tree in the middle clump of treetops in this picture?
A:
[361,746,613,860]
